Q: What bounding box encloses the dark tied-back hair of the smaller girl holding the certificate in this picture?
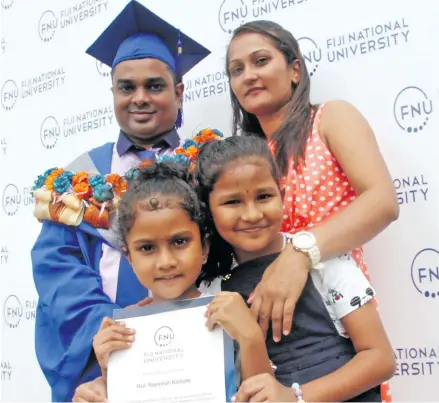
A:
[118,161,206,246]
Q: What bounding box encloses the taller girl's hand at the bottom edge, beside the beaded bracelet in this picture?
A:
[232,374,297,402]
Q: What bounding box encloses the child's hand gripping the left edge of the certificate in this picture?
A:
[93,317,135,378]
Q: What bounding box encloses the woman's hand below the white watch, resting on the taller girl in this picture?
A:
[248,245,311,342]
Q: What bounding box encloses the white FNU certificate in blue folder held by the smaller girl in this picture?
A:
[107,297,236,403]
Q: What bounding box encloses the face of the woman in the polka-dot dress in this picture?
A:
[228,33,299,116]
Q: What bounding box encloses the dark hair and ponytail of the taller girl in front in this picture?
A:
[195,136,279,285]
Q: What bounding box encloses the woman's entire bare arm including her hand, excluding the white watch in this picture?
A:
[248,101,399,341]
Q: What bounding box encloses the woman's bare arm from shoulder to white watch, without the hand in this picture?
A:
[311,101,399,260]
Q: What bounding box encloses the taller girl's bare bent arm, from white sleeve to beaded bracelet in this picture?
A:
[301,301,396,402]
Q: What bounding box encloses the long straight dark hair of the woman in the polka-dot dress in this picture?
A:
[226,20,316,175]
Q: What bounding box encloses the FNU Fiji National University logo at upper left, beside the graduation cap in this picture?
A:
[38,0,109,42]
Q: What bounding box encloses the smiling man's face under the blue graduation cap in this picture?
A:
[113,59,184,144]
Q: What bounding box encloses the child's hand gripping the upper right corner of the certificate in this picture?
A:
[205,291,262,342]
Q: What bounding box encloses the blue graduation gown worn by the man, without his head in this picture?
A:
[31,143,148,401]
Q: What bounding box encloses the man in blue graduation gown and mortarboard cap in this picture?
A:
[31,1,210,401]
